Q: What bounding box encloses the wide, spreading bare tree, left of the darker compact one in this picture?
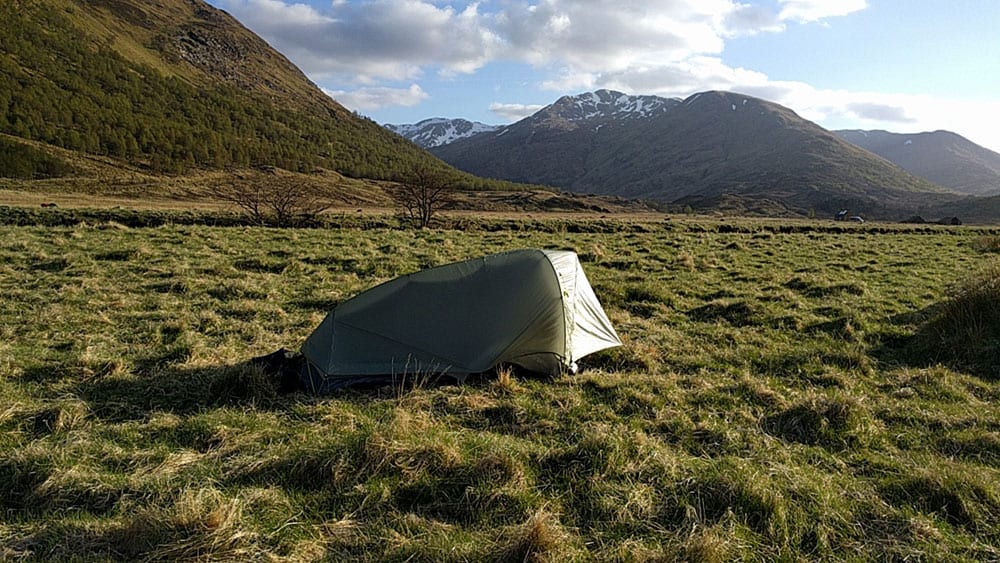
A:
[209,178,331,227]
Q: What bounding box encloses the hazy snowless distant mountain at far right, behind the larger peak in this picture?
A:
[834,130,1000,195]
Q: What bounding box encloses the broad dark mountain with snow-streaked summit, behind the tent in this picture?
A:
[432,91,957,217]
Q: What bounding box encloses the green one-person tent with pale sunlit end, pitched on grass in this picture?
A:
[302,250,621,391]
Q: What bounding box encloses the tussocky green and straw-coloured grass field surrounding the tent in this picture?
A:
[0,214,1000,561]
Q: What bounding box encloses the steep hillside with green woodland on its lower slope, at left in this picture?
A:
[0,0,500,189]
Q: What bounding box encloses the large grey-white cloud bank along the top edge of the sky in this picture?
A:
[223,0,832,83]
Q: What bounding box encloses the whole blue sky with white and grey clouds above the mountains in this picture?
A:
[208,0,1000,152]
